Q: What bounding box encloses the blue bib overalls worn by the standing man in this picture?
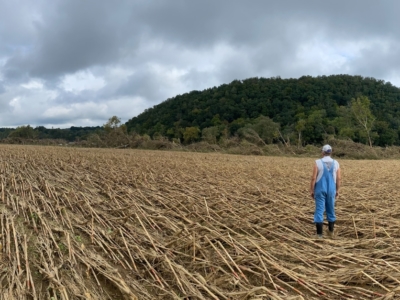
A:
[314,159,336,223]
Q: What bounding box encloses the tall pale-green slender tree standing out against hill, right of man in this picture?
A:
[350,96,376,147]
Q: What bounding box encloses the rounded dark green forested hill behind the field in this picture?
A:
[126,75,400,146]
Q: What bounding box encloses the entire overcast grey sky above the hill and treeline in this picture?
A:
[0,0,400,128]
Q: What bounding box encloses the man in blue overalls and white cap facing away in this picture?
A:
[310,145,341,238]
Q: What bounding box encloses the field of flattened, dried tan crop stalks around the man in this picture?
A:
[0,145,400,300]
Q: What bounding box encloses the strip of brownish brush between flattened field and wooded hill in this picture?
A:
[0,132,400,159]
